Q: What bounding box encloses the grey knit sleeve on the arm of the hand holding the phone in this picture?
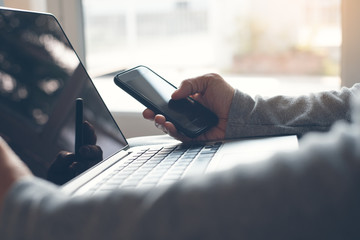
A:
[226,83,360,138]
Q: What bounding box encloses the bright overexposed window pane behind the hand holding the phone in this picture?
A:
[83,0,341,100]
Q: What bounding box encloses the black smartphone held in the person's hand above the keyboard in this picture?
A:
[114,66,219,138]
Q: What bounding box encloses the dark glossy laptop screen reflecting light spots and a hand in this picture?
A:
[0,9,127,184]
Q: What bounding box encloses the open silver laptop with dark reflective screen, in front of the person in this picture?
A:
[0,8,298,195]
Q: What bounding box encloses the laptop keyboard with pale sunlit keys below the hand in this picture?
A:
[88,143,221,194]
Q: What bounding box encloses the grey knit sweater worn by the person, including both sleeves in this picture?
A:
[0,85,360,240]
